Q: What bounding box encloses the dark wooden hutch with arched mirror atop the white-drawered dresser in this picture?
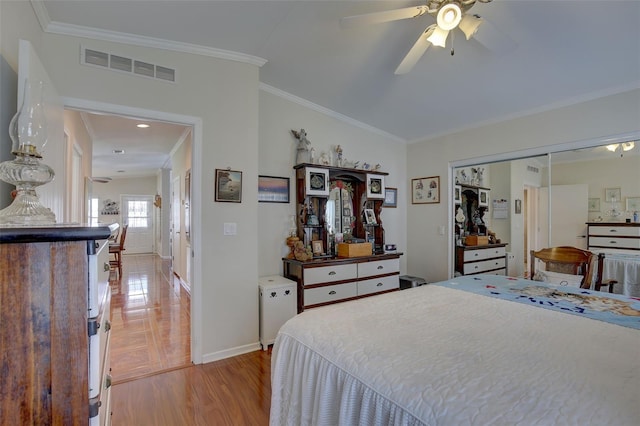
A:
[294,164,387,256]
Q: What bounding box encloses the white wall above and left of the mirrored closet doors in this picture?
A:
[407,90,640,280]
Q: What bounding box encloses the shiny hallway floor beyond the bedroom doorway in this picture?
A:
[110,254,191,384]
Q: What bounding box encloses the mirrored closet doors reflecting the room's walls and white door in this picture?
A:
[452,141,640,282]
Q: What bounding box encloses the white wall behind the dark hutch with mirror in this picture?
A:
[258,87,407,276]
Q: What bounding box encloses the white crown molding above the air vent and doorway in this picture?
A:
[30,0,267,67]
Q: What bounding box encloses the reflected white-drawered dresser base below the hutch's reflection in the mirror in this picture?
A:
[456,244,507,275]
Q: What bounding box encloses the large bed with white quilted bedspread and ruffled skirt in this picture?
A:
[270,275,640,426]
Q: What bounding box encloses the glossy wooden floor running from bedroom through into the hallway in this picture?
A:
[110,255,271,426]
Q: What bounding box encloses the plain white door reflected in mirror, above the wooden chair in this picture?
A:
[536,184,589,250]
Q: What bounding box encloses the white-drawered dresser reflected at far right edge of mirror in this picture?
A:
[587,222,640,253]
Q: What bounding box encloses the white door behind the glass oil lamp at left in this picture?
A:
[17,40,69,222]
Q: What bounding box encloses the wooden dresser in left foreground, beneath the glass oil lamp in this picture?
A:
[0,225,117,425]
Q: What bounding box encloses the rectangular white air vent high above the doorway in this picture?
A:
[80,47,176,83]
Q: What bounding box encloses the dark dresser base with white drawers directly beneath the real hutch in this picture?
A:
[283,253,400,312]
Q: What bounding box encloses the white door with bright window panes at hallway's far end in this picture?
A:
[121,195,153,254]
